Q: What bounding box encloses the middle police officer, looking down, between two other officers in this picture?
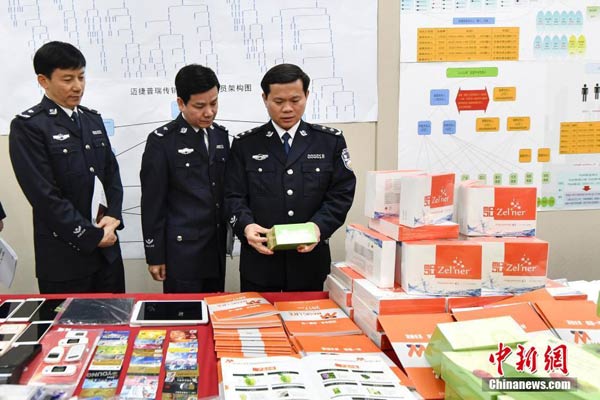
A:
[140,64,229,293]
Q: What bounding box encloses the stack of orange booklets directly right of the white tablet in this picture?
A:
[205,292,293,358]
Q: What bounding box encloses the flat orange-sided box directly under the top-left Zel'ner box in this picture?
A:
[369,217,458,242]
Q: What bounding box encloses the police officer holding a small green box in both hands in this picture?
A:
[225,64,356,291]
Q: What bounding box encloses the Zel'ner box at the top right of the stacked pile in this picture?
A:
[457,181,537,236]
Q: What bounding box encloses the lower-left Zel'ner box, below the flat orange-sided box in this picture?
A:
[400,240,482,296]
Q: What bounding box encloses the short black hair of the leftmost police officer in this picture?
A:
[33,41,85,79]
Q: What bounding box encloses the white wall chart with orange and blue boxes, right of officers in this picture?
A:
[398,0,600,211]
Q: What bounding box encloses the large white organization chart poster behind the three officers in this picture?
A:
[0,0,377,258]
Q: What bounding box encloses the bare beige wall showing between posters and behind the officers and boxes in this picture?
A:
[0,0,600,293]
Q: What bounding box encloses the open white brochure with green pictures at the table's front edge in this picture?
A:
[221,354,414,400]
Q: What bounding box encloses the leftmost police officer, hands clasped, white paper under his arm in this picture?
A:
[9,42,125,293]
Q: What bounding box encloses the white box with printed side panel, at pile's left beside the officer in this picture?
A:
[346,224,399,288]
